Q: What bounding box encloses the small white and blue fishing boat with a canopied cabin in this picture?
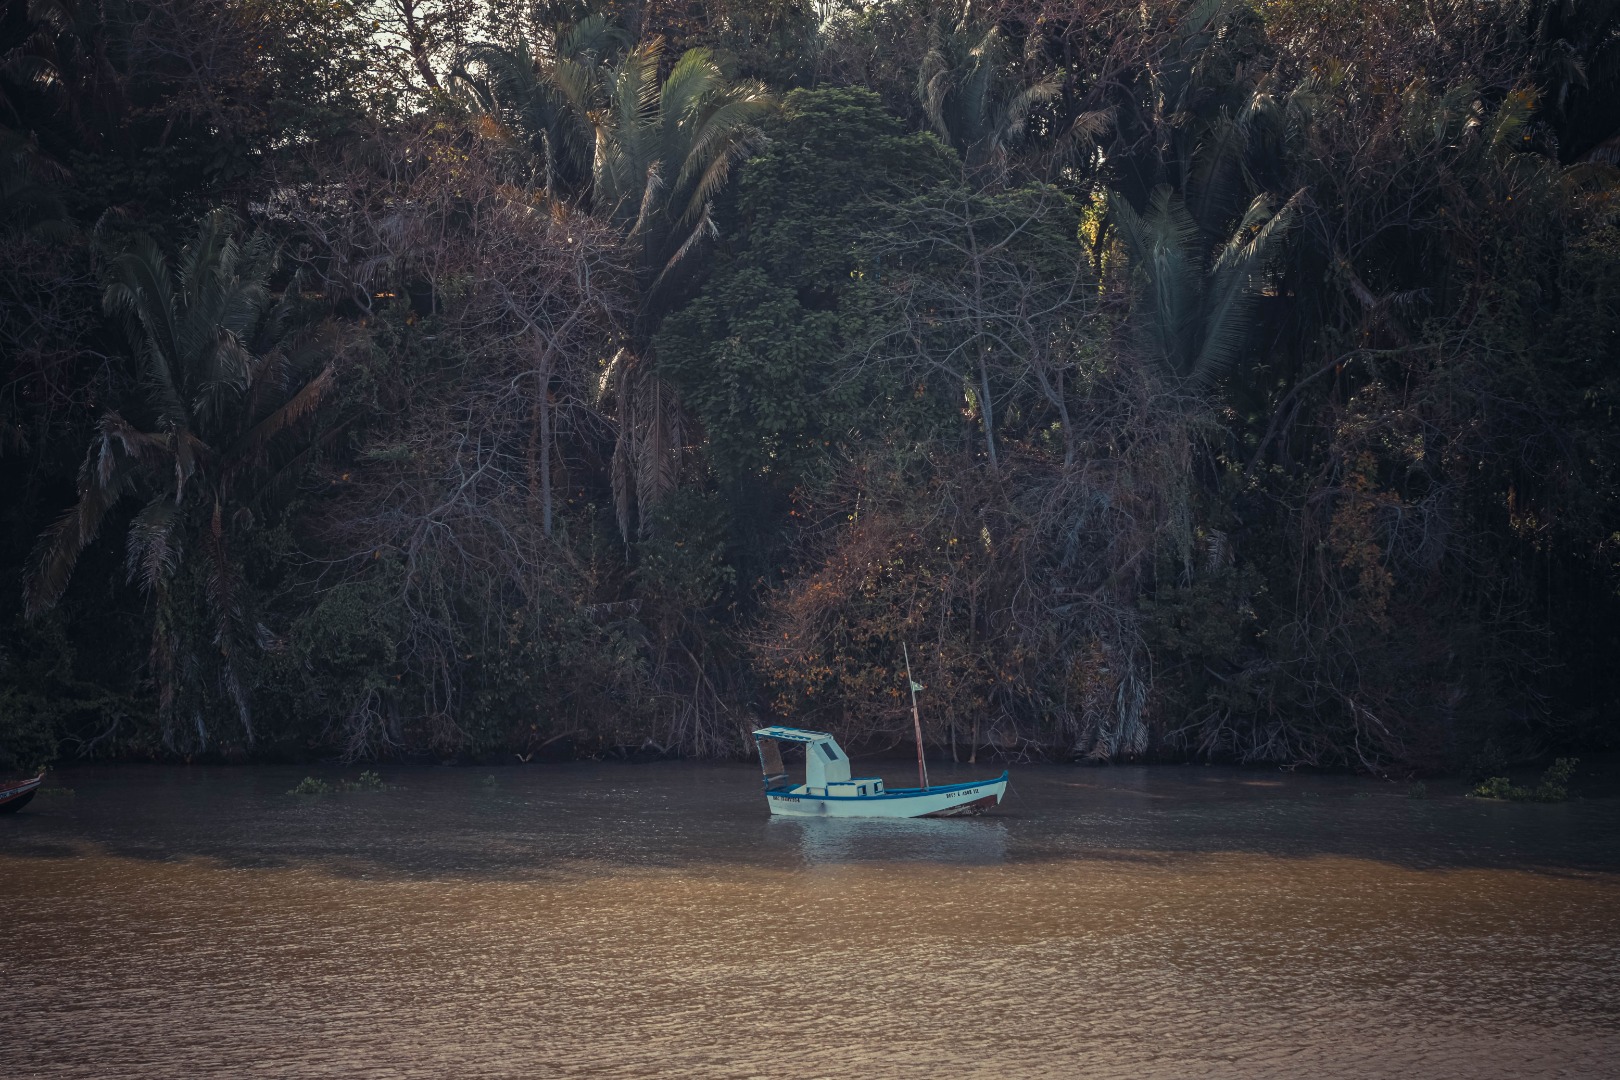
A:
[753,727,1008,818]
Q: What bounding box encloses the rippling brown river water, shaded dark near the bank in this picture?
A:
[0,764,1620,1078]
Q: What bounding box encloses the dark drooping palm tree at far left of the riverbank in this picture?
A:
[24,212,334,745]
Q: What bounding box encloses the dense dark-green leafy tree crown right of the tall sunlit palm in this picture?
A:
[658,87,954,491]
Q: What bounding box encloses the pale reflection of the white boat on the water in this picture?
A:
[765,818,1008,865]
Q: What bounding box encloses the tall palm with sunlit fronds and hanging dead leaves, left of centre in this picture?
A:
[468,27,773,538]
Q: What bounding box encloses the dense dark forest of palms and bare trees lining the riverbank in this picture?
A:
[0,0,1620,772]
